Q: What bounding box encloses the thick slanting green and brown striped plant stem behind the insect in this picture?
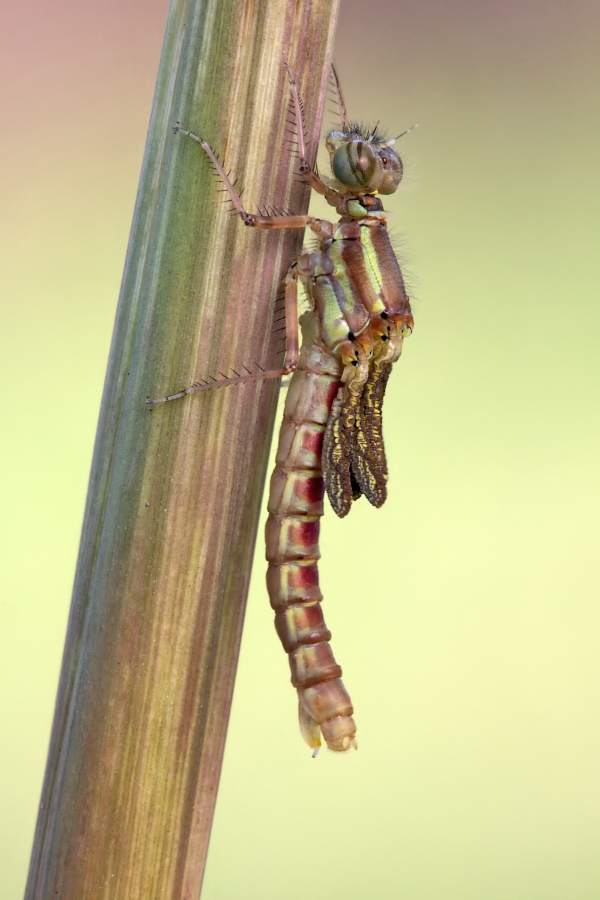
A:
[26,0,338,900]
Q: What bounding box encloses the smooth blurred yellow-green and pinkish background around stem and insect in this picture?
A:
[0,0,600,900]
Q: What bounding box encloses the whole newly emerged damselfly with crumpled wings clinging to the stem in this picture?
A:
[148,61,413,755]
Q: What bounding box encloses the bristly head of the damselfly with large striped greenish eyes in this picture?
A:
[326,125,402,194]
